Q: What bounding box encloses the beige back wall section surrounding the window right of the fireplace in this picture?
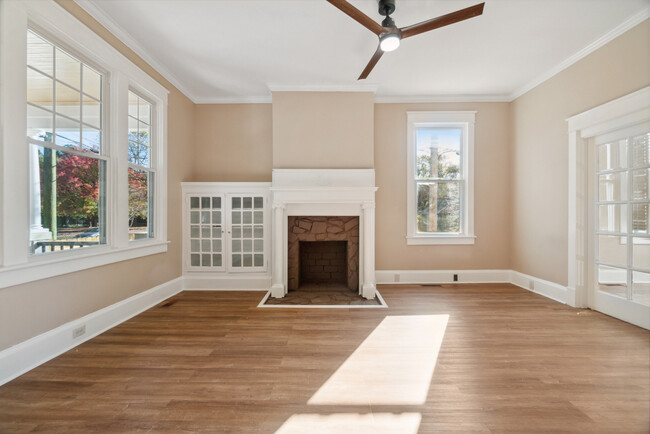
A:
[375,103,510,270]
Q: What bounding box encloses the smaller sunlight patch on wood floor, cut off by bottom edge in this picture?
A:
[276,413,422,434]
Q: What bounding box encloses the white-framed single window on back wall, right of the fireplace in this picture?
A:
[407,112,475,244]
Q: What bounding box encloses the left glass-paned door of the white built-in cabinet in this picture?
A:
[189,195,225,271]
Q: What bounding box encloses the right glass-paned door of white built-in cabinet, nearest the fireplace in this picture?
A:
[228,195,266,271]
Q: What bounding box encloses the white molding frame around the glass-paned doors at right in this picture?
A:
[566,86,650,316]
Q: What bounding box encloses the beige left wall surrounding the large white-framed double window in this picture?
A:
[0,0,194,350]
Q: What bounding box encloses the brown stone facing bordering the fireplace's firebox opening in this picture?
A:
[287,216,359,291]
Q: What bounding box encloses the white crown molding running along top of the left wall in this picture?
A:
[74,0,197,104]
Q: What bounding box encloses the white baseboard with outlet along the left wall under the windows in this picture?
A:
[0,277,183,386]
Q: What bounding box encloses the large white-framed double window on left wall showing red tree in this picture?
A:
[0,0,167,287]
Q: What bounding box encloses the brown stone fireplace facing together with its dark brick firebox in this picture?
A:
[287,216,359,291]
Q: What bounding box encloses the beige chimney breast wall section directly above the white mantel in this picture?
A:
[273,92,374,169]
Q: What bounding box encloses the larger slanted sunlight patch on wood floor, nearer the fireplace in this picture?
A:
[308,315,449,405]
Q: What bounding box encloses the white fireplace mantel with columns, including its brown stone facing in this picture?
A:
[271,169,377,299]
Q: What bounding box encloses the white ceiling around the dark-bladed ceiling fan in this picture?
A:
[77,0,650,103]
